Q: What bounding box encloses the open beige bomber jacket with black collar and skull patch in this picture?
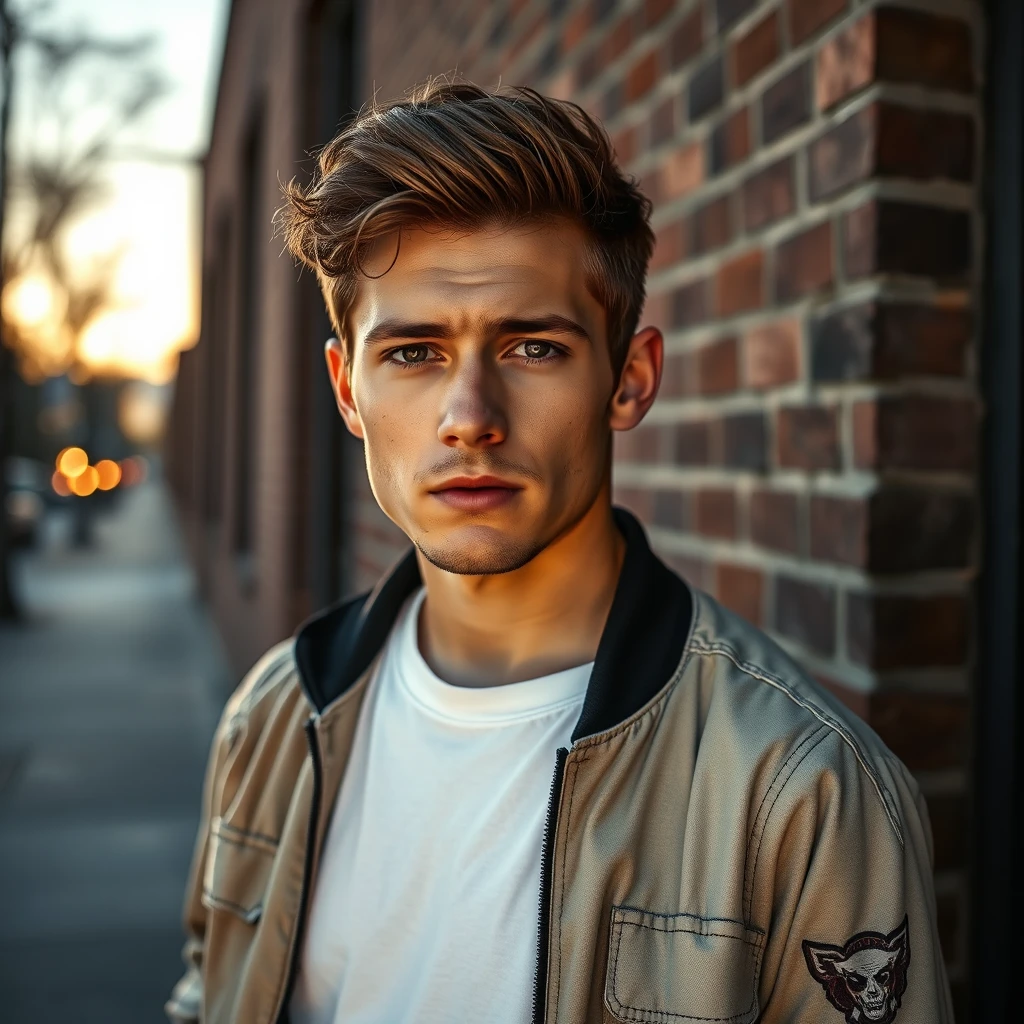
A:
[166,509,952,1024]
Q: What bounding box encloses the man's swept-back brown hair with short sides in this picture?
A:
[279,79,653,378]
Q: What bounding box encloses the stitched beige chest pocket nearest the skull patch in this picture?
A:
[604,906,764,1024]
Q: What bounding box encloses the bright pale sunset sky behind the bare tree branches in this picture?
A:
[5,0,228,382]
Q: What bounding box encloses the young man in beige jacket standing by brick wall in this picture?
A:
[168,83,952,1024]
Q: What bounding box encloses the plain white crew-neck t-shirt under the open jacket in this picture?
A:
[289,588,593,1024]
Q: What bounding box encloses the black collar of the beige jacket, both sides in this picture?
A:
[295,508,693,740]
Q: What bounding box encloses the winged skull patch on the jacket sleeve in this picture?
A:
[803,916,910,1024]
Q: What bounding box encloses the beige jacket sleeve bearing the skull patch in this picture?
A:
[752,726,953,1024]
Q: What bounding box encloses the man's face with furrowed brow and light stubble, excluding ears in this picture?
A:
[332,222,615,574]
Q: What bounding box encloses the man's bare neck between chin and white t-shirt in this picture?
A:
[417,496,626,686]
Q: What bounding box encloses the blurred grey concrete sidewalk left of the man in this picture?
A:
[0,483,230,1024]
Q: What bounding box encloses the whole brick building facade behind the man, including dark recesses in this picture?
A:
[163,0,1020,1020]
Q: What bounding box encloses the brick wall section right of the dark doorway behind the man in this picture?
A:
[366,0,983,1007]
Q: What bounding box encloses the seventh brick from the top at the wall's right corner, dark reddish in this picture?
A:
[846,594,970,672]
